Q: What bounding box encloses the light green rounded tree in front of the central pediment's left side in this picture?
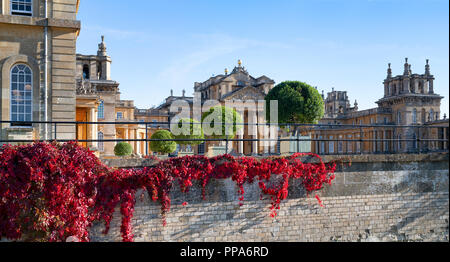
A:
[202,106,243,139]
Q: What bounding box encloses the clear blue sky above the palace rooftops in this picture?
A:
[77,0,449,116]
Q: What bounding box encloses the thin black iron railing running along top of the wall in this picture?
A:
[0,121,449,155]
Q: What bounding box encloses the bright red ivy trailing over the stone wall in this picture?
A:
[0,142,336,241]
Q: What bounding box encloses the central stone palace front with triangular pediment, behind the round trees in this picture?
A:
[145,60,278,156]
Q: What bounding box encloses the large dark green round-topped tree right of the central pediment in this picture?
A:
[265,81,324,124]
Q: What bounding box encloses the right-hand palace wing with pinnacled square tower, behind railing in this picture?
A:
[306,58,448,154]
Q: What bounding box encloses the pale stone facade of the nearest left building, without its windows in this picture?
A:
[0,0,80,142]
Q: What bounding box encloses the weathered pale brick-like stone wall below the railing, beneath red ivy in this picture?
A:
[91,154,449,242]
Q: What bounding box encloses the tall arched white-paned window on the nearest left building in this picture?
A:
[11,64,33,125]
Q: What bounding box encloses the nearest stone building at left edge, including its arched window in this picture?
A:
[0,0,80,143]
